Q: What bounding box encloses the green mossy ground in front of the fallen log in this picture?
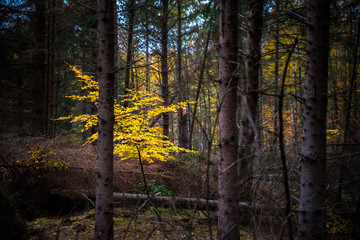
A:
[28,208,255,240]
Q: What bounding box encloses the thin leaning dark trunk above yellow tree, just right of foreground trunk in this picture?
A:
[124,0,135,103]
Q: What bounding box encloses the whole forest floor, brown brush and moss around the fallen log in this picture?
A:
[0,136,360,240]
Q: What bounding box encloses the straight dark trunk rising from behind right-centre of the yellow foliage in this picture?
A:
[161,0,170,137]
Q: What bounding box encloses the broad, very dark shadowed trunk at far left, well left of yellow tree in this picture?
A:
[32,0,46,135]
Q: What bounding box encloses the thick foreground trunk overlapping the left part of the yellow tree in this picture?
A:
[94,0,114,240]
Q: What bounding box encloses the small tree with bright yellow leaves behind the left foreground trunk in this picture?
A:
[57,66,192,163]
